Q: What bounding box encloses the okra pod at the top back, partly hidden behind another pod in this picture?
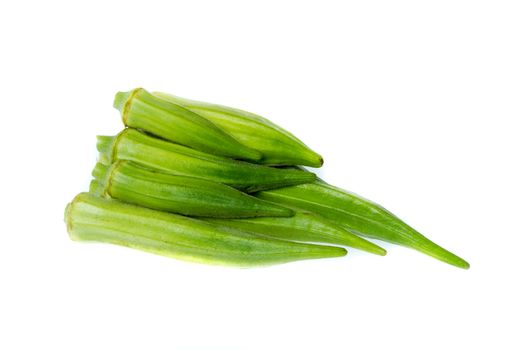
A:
[153,92,323,168]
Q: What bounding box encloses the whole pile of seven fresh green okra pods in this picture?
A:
[65,88,469,269]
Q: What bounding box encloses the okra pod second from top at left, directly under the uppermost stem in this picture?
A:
[97,129,316,192]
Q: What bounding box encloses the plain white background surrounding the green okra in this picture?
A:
[0,0,525,350]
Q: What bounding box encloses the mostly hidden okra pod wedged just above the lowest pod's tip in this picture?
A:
[206,211,386,255]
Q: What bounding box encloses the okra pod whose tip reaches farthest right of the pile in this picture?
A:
[256,181,469,269]
